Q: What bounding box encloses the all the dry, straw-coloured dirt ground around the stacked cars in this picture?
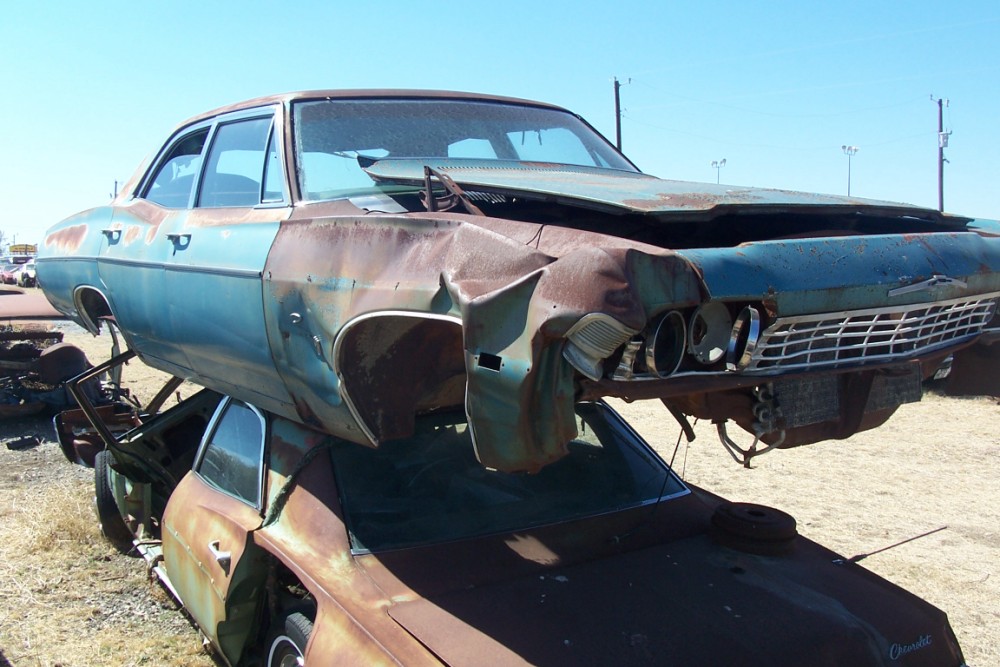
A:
[0,325,1000,667]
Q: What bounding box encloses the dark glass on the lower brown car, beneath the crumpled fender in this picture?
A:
[332,403,688,552]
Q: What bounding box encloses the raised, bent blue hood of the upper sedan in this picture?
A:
[365,158,966,222]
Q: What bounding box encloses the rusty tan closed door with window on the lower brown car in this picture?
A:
[162,398,268,663]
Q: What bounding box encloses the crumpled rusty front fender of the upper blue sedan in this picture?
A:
[264,214,707,471]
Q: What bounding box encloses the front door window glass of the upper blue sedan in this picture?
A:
[198,116,280,207]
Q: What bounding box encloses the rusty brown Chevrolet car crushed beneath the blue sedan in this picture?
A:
[74,390,964,666]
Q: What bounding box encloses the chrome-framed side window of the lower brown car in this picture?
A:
[195,400,265,507]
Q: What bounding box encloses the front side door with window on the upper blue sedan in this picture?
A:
[165,108,291,410]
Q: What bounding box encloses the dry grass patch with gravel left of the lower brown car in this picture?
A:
[0,422,216,667]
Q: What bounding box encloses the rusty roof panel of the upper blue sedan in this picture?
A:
[181,88,576,126]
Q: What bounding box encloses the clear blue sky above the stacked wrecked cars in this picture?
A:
[0,0,1000,243]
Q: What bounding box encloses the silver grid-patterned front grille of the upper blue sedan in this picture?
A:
[743,292,1000,373]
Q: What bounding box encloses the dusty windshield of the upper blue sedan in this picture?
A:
[294,99,636,201]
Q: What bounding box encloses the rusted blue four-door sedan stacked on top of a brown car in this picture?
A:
[38,91,1000,471]
